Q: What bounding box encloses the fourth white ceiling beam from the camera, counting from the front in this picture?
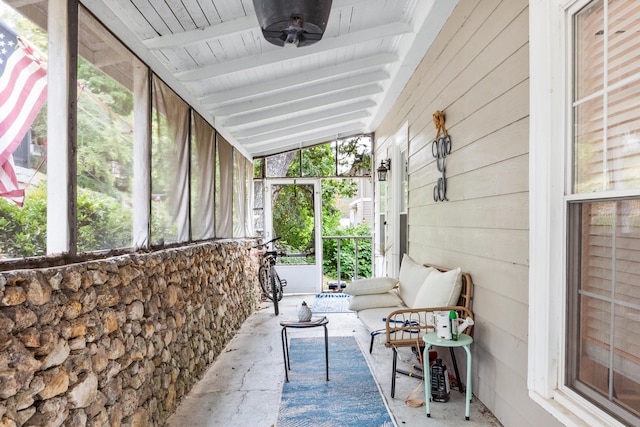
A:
[211,71,389,117]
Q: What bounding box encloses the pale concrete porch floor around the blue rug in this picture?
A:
[166,295,501,427]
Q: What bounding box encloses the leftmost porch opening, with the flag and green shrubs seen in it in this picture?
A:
[0,1,48,259]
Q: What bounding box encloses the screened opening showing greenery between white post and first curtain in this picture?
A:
[77,7,137,252]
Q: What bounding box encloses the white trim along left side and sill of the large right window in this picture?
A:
[527,0,623,426]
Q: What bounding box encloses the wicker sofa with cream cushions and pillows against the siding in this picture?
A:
[344,255,473,397]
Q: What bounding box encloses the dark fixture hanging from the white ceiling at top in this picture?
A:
[253,0,333,47]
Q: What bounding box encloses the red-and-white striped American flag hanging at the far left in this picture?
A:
[0,21,47,206]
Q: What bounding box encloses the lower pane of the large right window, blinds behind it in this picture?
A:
[569,199,640,422]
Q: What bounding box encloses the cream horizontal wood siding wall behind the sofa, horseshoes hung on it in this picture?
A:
[375,0,560,426]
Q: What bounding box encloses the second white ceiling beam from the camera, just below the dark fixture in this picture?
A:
[175,22,412,82]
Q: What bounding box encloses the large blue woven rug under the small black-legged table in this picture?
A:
[276,337,395,427]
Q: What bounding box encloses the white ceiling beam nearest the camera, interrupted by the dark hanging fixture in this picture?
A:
[142,0,366,49]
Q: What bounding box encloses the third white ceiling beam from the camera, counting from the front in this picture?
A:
[198,53,398,107]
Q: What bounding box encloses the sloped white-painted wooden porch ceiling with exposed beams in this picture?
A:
[15,0,457,157]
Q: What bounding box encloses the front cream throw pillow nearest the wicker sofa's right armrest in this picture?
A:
[411,267,462,308]
